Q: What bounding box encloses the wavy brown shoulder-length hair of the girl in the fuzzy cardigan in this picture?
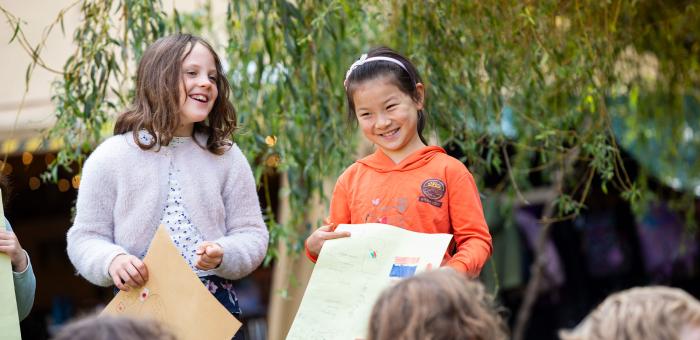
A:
[114,33,236,155]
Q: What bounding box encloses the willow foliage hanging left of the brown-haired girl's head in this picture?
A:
[44,0,172,181]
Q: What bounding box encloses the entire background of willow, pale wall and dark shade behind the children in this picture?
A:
[0,0,700,339]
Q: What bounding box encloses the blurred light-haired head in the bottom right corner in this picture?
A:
[559,286,700,340]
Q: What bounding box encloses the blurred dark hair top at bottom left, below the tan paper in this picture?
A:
[53,315,177,340]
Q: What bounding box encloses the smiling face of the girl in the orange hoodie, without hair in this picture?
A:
[352,76,425,164]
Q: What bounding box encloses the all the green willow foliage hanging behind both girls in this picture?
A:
[2,0,700,255]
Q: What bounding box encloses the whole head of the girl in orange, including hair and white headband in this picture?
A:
[345,47,427,150]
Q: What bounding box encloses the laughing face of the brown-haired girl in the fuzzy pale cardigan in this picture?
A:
[175,43,219,136]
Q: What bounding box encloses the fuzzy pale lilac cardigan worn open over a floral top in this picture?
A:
[67,132,269,286]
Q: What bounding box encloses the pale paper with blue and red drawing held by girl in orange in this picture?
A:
[287,223,452,340]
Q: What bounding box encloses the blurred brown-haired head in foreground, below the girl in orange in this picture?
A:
[367,269,507,340]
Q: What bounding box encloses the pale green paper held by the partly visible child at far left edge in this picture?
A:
[0,190,22,340]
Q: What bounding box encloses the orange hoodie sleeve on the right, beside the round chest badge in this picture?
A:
[446,170,493,277]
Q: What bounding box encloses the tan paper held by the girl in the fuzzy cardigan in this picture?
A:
[102,225,241,340]
